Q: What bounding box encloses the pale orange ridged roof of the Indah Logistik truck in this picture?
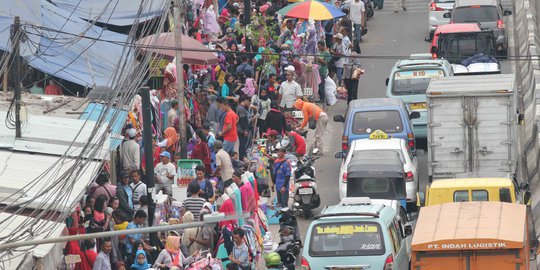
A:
[412,202,527,250]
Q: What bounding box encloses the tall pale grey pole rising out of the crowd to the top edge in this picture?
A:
[173,0,187,159]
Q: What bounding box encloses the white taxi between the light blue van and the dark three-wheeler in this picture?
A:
[336,136,419,210]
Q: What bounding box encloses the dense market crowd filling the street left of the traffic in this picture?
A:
[66,0,365,270]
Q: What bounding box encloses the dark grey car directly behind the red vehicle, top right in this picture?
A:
[444,0,512,56]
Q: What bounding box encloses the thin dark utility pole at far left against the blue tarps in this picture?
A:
[11,16,21,138]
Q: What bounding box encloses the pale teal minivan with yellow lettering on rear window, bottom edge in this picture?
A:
[301,198,412,270]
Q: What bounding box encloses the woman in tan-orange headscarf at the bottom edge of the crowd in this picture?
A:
[154,235,199,269]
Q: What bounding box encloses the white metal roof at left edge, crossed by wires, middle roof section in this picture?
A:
[0,150,101,211]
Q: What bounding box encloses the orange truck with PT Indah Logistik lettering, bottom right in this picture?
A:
[411,202,538,270]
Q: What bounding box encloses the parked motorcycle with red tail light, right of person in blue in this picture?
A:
[294,149,321,219]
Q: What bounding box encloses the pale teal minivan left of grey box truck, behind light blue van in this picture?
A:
[386,53,453,138]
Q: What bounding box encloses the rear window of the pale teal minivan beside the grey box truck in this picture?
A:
[392,69,444,95]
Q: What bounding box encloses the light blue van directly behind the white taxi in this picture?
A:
[334,98,420,154]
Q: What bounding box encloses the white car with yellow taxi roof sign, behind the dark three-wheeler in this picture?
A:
[336,138,419,209]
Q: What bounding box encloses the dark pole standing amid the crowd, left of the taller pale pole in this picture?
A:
[139,87,158,246]
